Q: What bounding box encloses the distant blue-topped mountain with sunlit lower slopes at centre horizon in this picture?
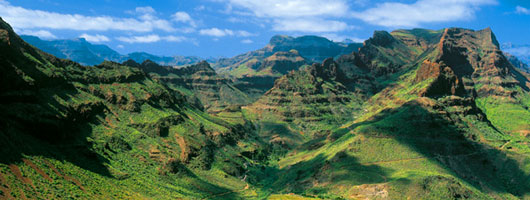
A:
[213,35,362,100]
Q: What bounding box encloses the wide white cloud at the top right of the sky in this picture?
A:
[353,0,497,27]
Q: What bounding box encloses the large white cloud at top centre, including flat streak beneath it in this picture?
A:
[220,0,351,32]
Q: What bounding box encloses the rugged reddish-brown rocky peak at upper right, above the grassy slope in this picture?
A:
[416,28,528,97]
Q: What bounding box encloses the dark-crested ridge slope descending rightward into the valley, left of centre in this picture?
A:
[123,60,250,113]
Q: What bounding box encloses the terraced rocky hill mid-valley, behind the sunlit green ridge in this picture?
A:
[245,58,374,136]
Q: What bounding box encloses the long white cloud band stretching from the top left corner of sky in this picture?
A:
[0,1,175,32]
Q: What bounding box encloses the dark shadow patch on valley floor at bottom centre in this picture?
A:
[253,152,389,198]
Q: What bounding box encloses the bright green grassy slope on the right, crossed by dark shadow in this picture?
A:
[242,28,530,199]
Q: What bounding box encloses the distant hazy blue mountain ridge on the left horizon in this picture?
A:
[21,35,211,66]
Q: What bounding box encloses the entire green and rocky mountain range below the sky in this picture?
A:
[0,16,530,199]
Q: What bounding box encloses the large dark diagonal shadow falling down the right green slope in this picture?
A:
[352,101,530,196]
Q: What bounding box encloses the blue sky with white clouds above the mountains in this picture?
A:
[0,0,530,58]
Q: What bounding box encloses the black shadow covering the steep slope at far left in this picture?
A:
[0,84,111,177]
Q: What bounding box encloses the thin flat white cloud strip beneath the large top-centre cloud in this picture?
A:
[273,19,349,32]
